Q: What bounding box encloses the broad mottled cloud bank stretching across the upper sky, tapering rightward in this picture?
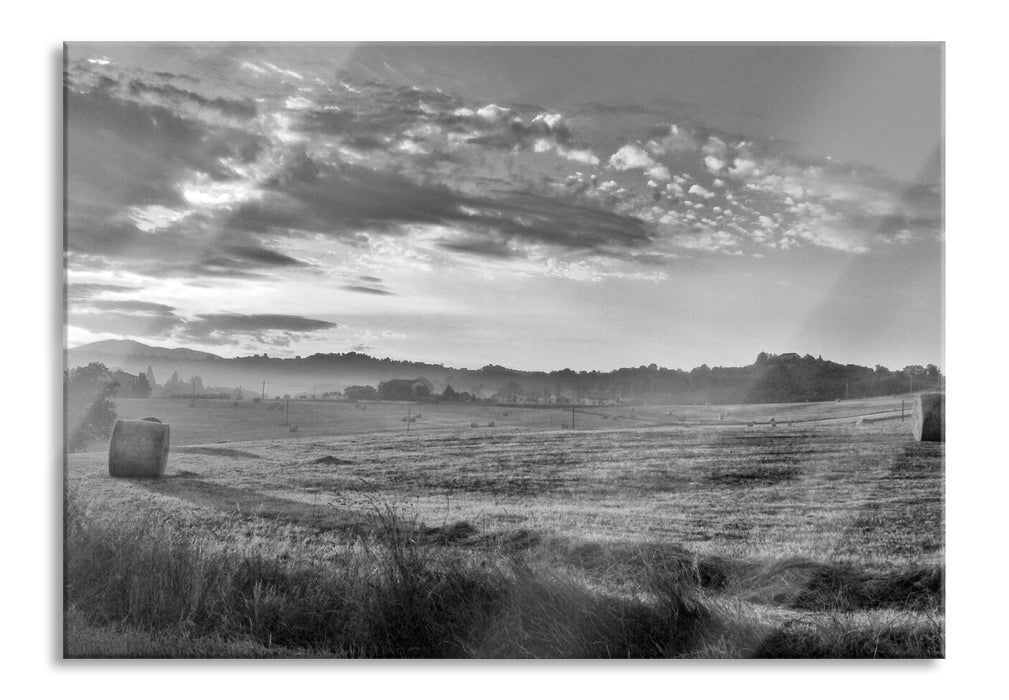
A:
[68,54,940,284]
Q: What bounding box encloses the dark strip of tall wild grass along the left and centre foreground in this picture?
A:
[65,495,711,658]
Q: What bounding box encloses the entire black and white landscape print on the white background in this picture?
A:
[59,40,944,668]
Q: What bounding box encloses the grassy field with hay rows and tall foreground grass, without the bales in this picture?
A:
[66,397,944,658]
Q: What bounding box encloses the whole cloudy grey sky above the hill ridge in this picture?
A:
[66,43,943,370]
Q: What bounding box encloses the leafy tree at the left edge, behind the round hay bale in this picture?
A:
[64,362,119,452]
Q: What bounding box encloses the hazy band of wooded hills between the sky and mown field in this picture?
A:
[68,340,942,403]
